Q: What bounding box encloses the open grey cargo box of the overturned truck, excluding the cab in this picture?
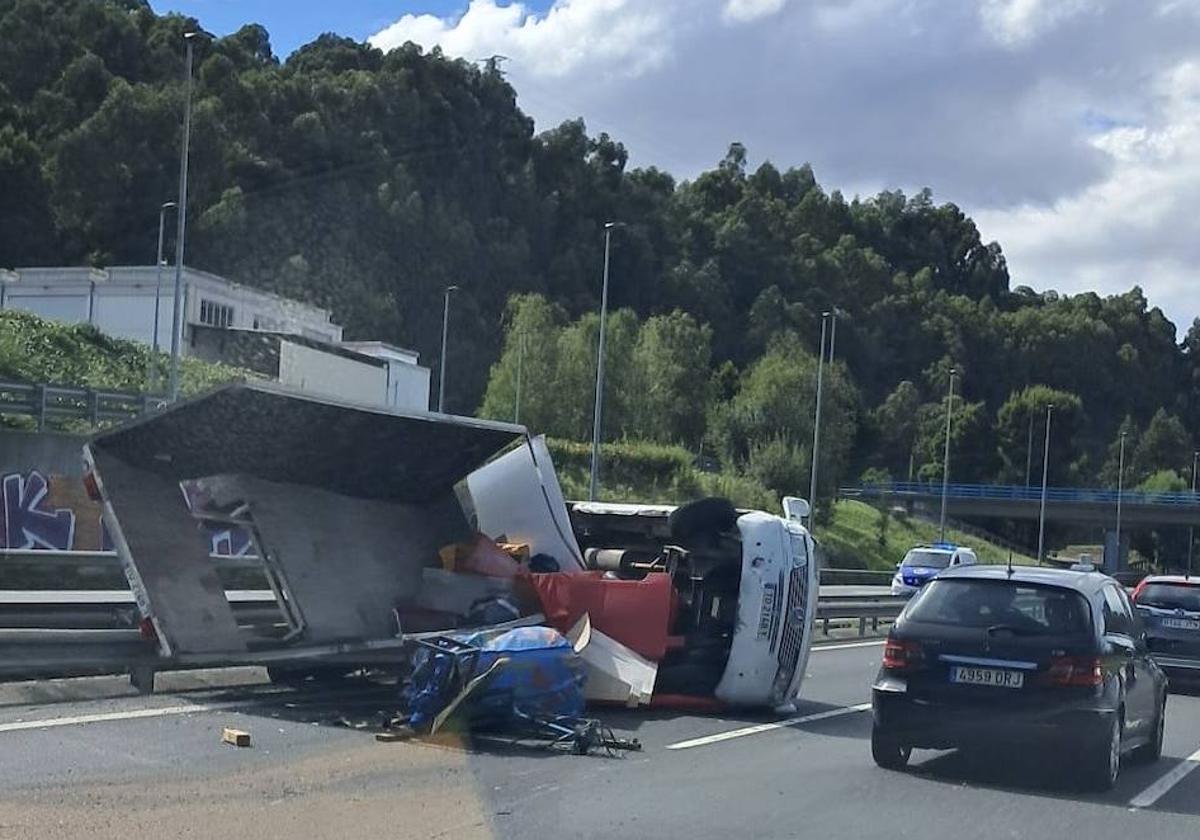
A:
[85,384,526,658]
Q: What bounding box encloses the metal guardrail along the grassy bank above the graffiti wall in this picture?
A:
[0,382,167,431]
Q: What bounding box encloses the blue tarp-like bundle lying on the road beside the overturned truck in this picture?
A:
[409,626,584,730]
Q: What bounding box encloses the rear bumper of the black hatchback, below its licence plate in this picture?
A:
[871,680,1115,749]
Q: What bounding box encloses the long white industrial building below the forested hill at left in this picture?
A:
[0,265,430,410]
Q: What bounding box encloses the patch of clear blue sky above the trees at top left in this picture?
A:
[150,0,551,58]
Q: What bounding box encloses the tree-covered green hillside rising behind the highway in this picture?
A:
[0,0,1200,516]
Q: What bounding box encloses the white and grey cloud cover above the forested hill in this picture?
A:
[372,0,1200,324]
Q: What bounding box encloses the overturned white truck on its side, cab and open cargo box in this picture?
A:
[84,383,817,707]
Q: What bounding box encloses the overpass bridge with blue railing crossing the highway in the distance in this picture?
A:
[839,481,1200,528]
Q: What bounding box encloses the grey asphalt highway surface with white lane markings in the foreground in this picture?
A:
[0,641,1200,840]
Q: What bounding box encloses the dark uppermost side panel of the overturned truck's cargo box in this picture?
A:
[91,383,524,503]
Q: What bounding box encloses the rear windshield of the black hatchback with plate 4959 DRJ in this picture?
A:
[906,578,1091,636]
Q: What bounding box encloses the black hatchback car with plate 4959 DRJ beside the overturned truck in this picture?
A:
[871,566,1166,790]
